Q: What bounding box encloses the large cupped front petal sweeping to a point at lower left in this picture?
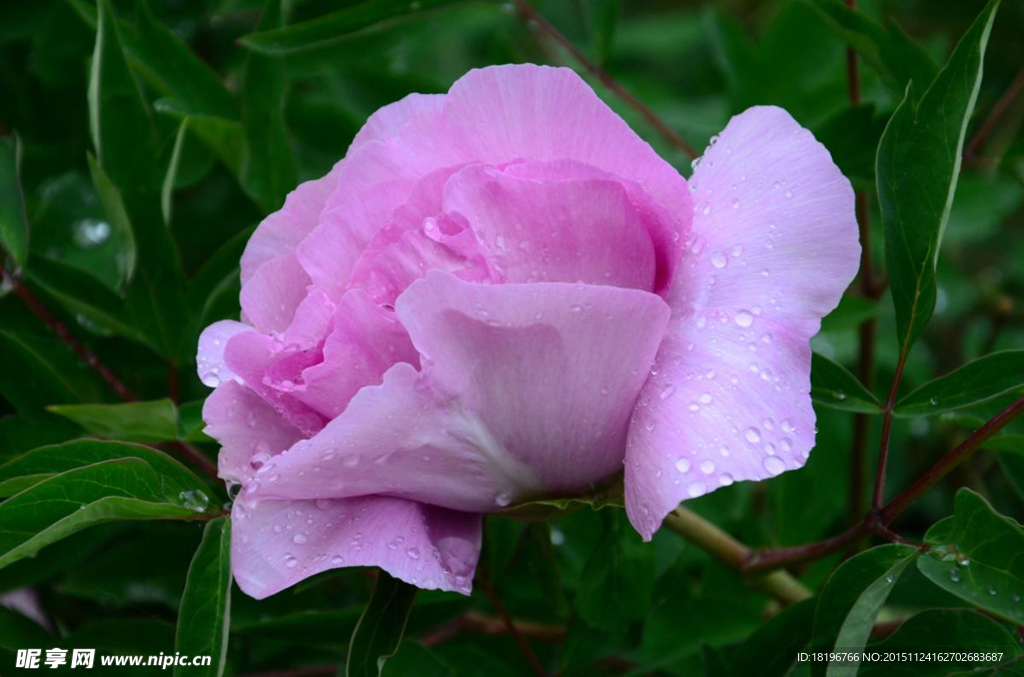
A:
[249,271,669,512]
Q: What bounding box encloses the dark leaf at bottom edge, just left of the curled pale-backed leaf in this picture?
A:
[729,599,817,677]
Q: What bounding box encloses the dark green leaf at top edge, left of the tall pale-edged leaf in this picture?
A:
[809,0,935,96]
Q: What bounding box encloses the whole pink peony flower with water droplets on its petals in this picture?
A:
[198,66,860,598]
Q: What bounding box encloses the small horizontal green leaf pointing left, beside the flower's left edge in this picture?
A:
[47,398,178,442]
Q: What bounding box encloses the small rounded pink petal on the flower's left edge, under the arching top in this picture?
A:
[239,252,309,332]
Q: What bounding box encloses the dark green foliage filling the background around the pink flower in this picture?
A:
[0,0,1024,677]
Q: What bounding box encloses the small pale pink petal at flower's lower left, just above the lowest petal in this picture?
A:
[203,381,302,483]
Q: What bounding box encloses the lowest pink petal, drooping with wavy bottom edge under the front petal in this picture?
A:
[231,496,481,599]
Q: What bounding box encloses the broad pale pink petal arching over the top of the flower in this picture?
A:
[300,65,692,298]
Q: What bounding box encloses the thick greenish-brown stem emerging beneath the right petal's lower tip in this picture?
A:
[665,506,811,604]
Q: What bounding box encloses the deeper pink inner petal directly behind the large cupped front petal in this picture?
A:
[443,165,657,291]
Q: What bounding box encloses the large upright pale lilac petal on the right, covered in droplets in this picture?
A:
[626,107,860,539]
